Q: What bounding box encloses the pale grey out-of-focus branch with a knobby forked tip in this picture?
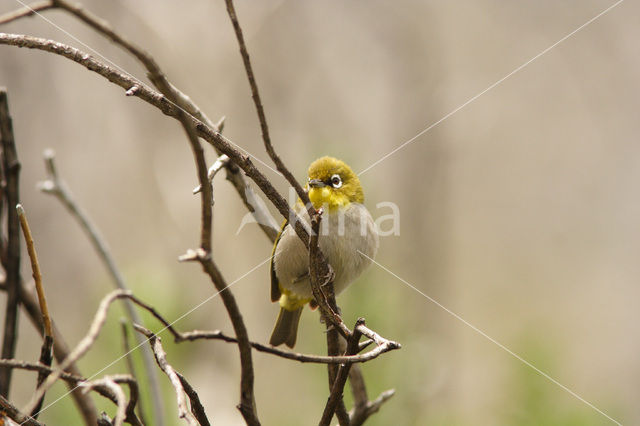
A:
[38,149,164,424]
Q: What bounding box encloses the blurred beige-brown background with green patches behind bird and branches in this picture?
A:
[0,0,640,425]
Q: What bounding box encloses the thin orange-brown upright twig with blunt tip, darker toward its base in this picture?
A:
[16,204,53,420]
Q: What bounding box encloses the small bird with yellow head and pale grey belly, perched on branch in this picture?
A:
[269,157,378,348]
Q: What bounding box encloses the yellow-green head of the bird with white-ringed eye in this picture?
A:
[307,157,364,210]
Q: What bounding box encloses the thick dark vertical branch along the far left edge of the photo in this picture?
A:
[0,88,20,397]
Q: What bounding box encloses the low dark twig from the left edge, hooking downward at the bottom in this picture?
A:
[0,359,144,426]
